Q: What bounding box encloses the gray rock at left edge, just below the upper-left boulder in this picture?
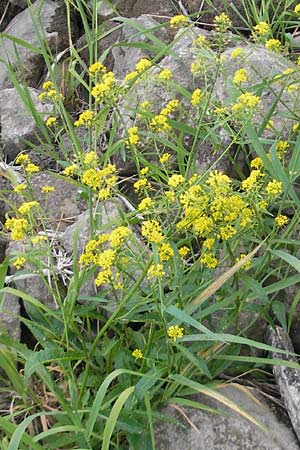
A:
[0,87,52,161]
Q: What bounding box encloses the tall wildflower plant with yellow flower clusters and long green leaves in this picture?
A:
[0,1,299,450]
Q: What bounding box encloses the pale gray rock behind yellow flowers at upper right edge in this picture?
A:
[213,44,300,139]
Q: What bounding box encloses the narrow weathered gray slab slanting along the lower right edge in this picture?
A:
[267,326,300,441]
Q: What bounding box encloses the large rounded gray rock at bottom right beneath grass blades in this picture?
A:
[155,387,299,450]
